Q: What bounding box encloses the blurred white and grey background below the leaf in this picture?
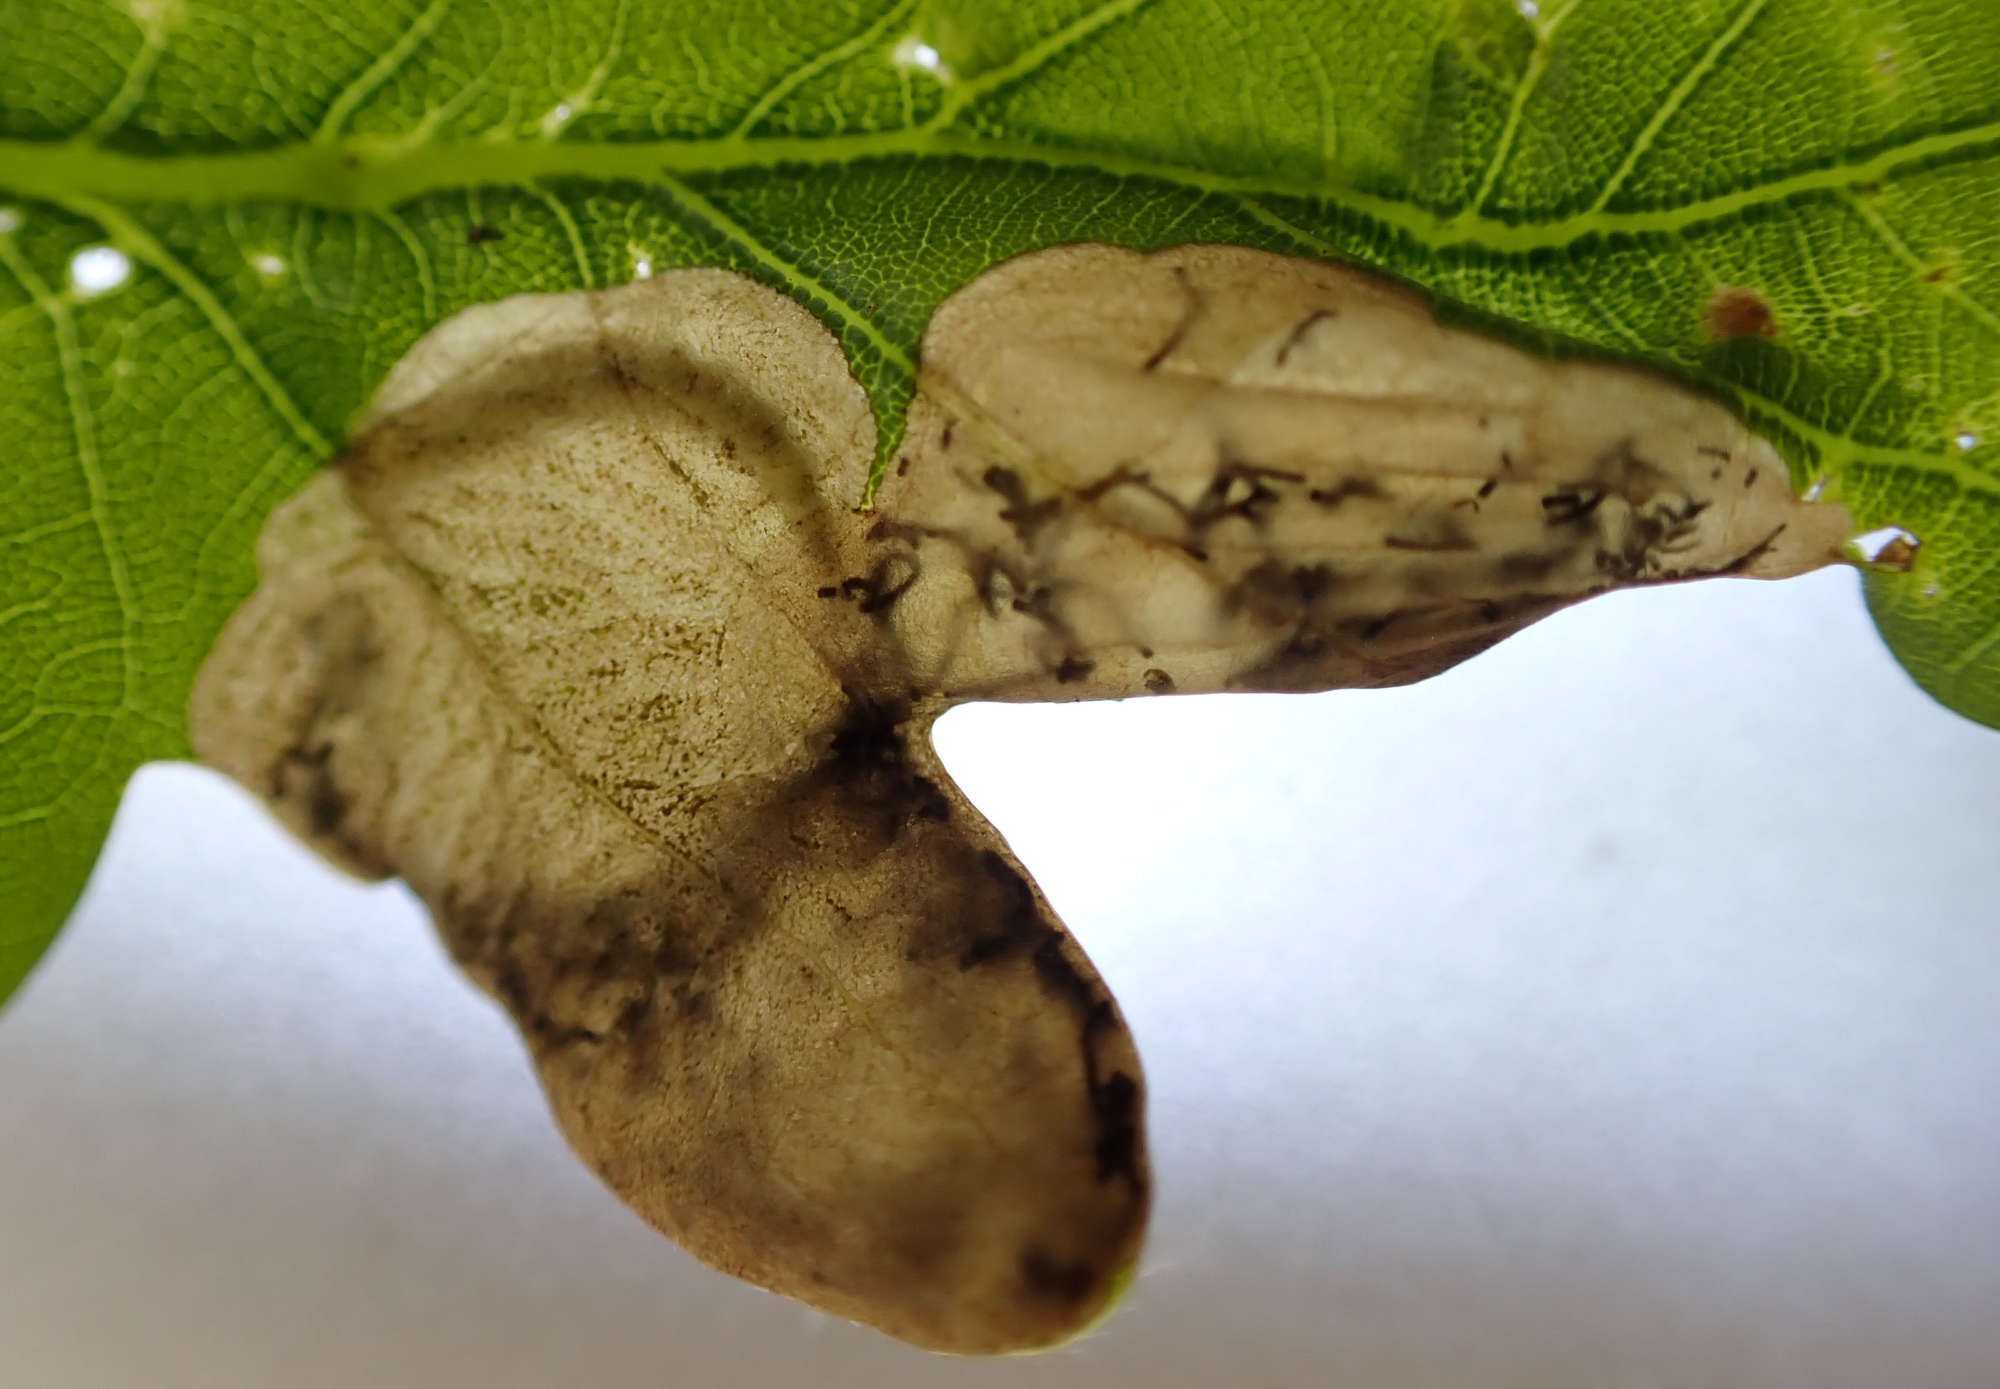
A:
[0,572,2000,1389]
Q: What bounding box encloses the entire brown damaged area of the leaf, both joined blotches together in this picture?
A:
[190,246,1852,1351]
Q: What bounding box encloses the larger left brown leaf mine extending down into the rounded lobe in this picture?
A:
[192,272,1150,1351]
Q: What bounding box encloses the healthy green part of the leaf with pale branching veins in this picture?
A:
[0,0,2000,995]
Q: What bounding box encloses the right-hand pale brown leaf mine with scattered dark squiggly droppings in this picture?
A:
[872,246,1854,699]
